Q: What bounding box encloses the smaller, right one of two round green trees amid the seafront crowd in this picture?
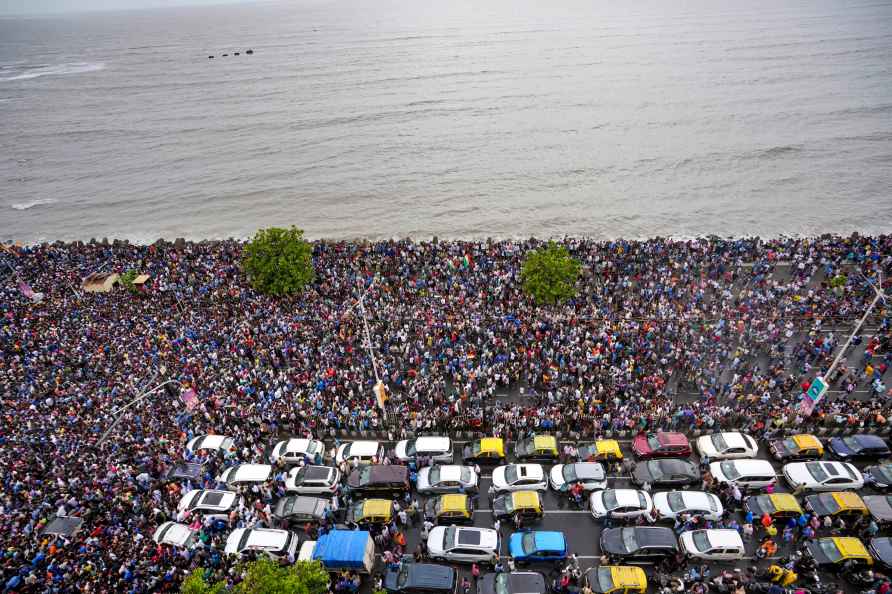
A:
[520,241,582,305]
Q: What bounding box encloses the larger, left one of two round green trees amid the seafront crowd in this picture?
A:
[242,226,316,295]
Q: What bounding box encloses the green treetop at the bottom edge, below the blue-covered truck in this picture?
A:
[235,557,329,594]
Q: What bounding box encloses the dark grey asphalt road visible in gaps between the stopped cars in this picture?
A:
[324,430,887,592]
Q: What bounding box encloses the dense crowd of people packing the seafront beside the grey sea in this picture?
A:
[0,235,892,592]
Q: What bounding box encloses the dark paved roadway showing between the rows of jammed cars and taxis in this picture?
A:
[324,430,885,592]
